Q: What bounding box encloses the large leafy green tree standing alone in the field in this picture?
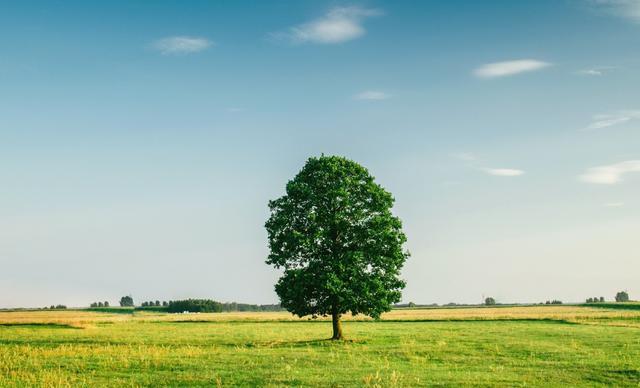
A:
[265,155,409,339]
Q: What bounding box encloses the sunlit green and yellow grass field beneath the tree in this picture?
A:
[0,305,640,387]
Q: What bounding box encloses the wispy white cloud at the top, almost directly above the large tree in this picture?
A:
[271,6,382,44]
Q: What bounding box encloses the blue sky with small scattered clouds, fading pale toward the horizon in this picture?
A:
[0,0,640,307]
